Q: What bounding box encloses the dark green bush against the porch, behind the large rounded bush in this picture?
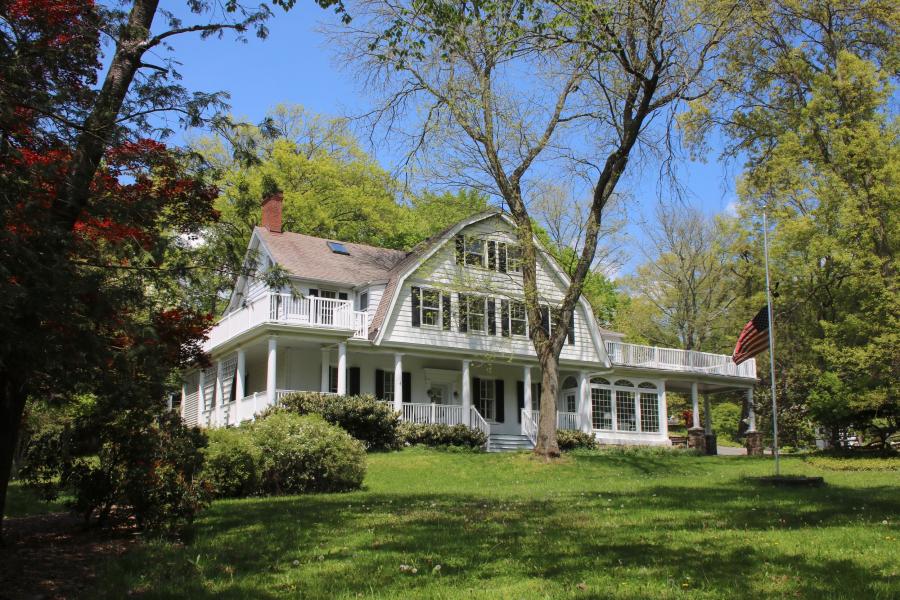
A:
[263,392,400,450]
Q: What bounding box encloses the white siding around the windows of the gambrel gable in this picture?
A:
[384,218,600,362]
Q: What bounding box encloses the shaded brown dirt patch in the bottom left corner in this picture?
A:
[0,513,136,600]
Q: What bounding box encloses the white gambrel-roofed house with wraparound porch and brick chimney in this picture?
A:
[181,195,756,450]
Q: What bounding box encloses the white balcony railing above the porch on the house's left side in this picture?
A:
[206,293,369,350]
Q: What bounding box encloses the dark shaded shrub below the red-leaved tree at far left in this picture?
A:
[22,410,208,531]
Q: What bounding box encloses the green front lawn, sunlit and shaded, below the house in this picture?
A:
[87,449,900,599]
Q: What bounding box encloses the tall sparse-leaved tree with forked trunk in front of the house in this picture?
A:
[338,0,729,456]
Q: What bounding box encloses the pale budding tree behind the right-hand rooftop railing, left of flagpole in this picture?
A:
[621,204,740,351]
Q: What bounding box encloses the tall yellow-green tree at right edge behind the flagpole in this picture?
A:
[693,0,900,443]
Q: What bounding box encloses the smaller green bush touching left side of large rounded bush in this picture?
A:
[203,428,262,498]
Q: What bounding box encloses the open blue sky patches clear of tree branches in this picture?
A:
[162,0,735,272]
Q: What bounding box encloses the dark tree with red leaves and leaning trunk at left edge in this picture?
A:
[0,0,343,536]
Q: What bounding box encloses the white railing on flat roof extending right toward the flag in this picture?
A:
[606,342,756,379]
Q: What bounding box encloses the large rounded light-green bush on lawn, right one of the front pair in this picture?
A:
[250,411,366,494]
